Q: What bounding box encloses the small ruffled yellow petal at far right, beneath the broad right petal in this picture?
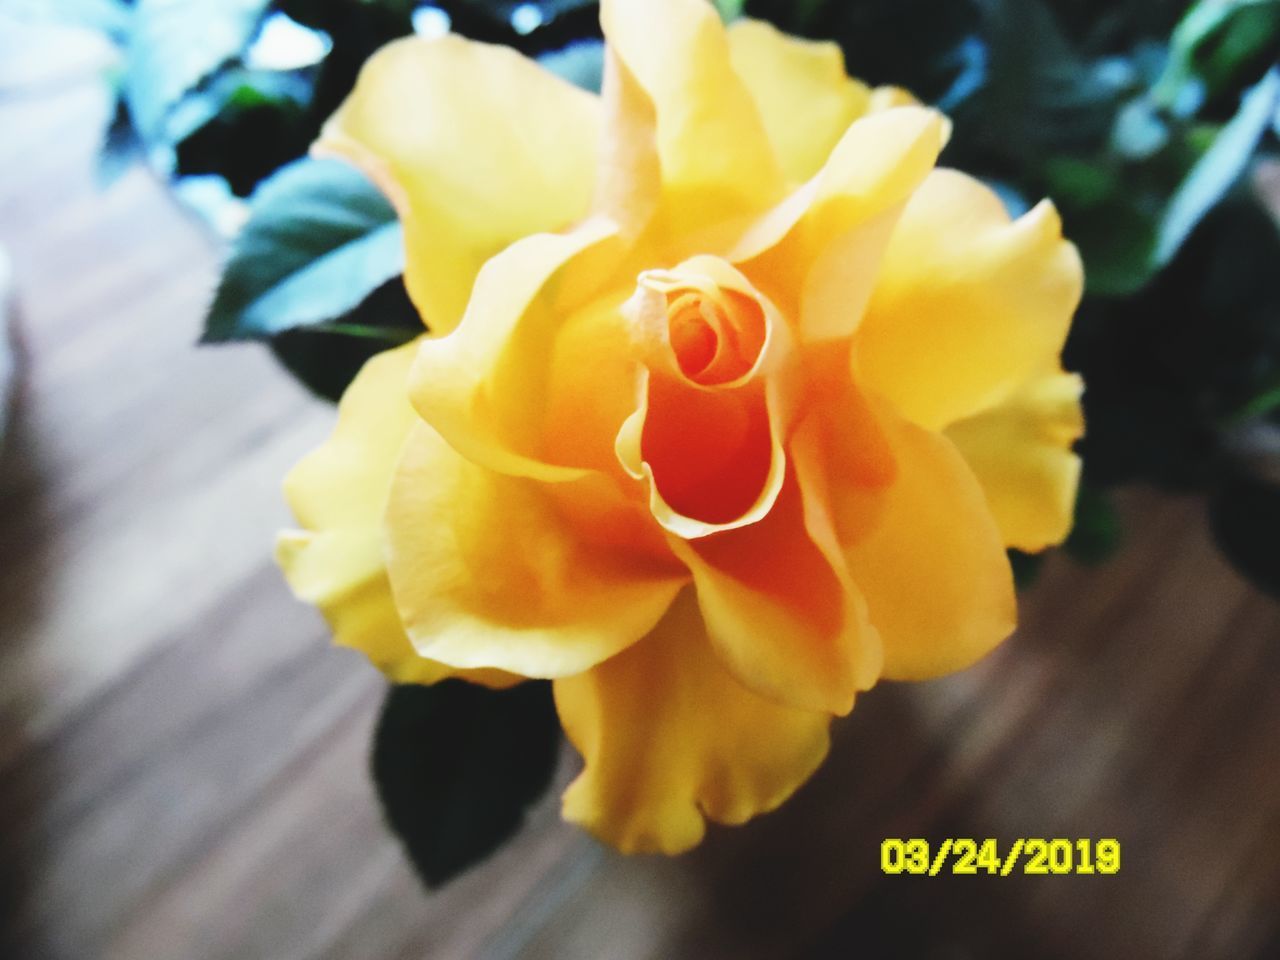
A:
[946,370,1084,550]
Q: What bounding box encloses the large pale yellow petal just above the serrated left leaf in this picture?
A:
[316,36,599,333]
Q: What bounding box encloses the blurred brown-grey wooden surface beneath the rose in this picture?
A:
[0,50,1280,960]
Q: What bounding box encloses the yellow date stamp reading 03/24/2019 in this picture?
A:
[881,837,1120,877]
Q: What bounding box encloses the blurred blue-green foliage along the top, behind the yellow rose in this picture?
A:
[27,0,1280,591]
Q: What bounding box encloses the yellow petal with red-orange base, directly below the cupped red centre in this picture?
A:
[672,471,881,714]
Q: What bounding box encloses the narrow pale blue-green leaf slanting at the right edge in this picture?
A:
[1152,67,1280,266]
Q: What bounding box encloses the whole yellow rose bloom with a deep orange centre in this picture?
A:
[279,0,1082,852]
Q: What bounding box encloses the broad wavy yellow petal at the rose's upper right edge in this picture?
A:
[856,170,1083,430]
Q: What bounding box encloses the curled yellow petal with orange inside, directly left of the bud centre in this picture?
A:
[410,220,624,483]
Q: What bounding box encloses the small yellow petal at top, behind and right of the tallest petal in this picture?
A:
[728,19,872,182]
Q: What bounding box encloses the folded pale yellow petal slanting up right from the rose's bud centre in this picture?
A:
[728,106,945,340]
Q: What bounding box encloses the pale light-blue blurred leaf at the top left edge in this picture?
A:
[125,0,269,141]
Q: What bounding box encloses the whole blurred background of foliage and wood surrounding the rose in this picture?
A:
[0,0,1280,960]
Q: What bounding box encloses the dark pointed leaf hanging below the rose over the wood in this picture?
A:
[372,680,559,887]
